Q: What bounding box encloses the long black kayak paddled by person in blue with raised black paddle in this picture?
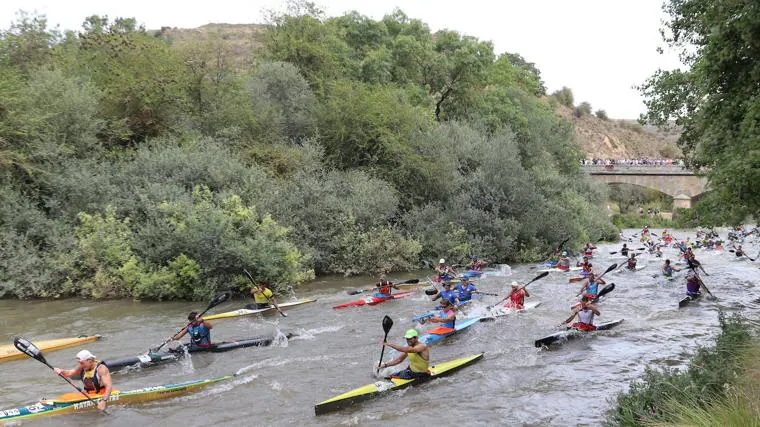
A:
[103,334,292,371]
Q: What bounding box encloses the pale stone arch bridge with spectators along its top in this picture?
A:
[581,165,708,208]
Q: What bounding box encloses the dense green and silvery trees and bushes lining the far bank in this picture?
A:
[0,2,617,299]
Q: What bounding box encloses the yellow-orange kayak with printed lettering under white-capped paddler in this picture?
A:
[0,375,234,424]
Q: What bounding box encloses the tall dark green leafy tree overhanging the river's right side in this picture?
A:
[639,0,760,223]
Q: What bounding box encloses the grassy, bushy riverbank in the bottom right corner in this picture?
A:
[607,314,760,426]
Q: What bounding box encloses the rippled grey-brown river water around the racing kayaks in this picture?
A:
[0,230,760,426]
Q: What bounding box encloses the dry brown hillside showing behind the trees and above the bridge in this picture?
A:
[156,24,681,159]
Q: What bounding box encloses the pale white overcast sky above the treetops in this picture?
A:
[0,0,682,119]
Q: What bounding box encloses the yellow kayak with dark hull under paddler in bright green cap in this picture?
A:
[314,353,483,415]
